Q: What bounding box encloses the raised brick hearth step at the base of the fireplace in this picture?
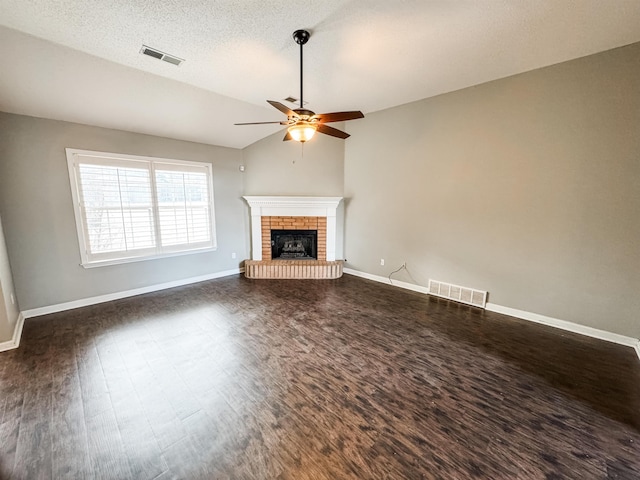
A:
[244,260,344,280]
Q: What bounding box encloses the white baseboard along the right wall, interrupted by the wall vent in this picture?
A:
[344,268,640,359]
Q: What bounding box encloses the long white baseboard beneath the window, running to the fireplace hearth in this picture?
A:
[22,268,244,318]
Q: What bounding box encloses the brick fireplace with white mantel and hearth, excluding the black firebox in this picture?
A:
[244,196,342,278]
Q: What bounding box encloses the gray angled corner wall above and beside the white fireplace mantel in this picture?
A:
[242,126,352,259]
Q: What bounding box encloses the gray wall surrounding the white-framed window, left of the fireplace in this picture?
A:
[0,113,249,311]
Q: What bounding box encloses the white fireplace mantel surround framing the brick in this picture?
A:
[243,196,342,261]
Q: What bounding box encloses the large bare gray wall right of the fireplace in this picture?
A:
[345,44,640,338]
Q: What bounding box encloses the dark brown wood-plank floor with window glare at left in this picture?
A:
[0,276,640,480]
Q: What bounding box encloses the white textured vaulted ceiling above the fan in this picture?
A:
[0,0,640,148]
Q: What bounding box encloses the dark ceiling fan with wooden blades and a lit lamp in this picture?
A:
[235,30,364,143]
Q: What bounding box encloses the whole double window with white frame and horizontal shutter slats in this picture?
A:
[66,148,216,267]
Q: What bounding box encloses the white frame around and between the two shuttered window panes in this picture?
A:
[65,148,217,268]
